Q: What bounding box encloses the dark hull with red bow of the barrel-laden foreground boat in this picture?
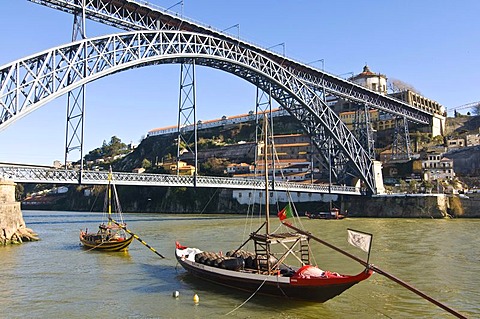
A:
[175,245,373,303]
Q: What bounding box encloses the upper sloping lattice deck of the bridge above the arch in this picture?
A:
[29,0,433,124]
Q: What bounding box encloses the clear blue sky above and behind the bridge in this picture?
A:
[0,0,480,165]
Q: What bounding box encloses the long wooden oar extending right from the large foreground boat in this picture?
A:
[283,223,467,319]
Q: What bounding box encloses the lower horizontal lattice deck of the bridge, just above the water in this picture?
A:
[0,165,361,195]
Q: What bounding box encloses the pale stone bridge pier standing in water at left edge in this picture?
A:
[0,178,38,245]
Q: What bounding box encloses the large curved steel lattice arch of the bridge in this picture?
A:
[0,30,376,193]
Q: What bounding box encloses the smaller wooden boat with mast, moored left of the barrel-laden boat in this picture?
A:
[80,168,134,251]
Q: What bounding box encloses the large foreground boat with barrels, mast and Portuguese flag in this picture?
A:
[175,116,373,303]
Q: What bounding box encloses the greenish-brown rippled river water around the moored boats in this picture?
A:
[0,211,480,319]
